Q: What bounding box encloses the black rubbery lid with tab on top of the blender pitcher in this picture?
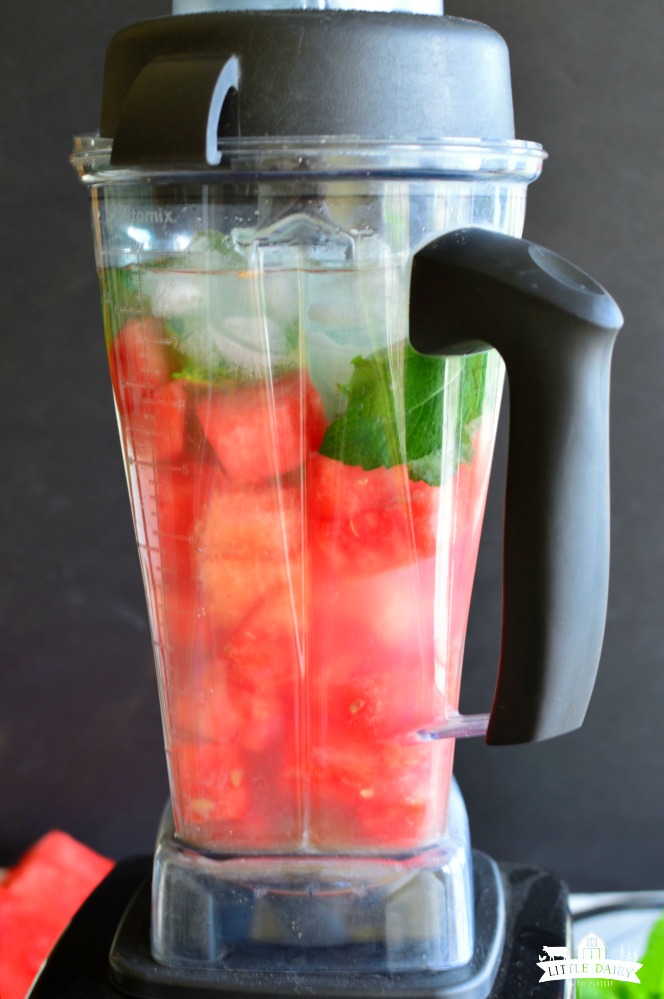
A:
[100,10,514,170]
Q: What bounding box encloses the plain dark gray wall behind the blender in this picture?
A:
[0,0,664,889]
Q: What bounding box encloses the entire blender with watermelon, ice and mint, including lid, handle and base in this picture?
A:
[35,0,622,999]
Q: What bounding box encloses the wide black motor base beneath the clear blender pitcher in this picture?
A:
[24,852,570,999]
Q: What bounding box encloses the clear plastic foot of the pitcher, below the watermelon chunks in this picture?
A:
[150,781,478,972]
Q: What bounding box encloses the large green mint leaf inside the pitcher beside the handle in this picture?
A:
[320,342,487,485]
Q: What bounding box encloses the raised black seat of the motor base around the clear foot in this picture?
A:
[111,854,505,999]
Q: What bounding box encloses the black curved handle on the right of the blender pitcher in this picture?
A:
[410,229,623,745]
